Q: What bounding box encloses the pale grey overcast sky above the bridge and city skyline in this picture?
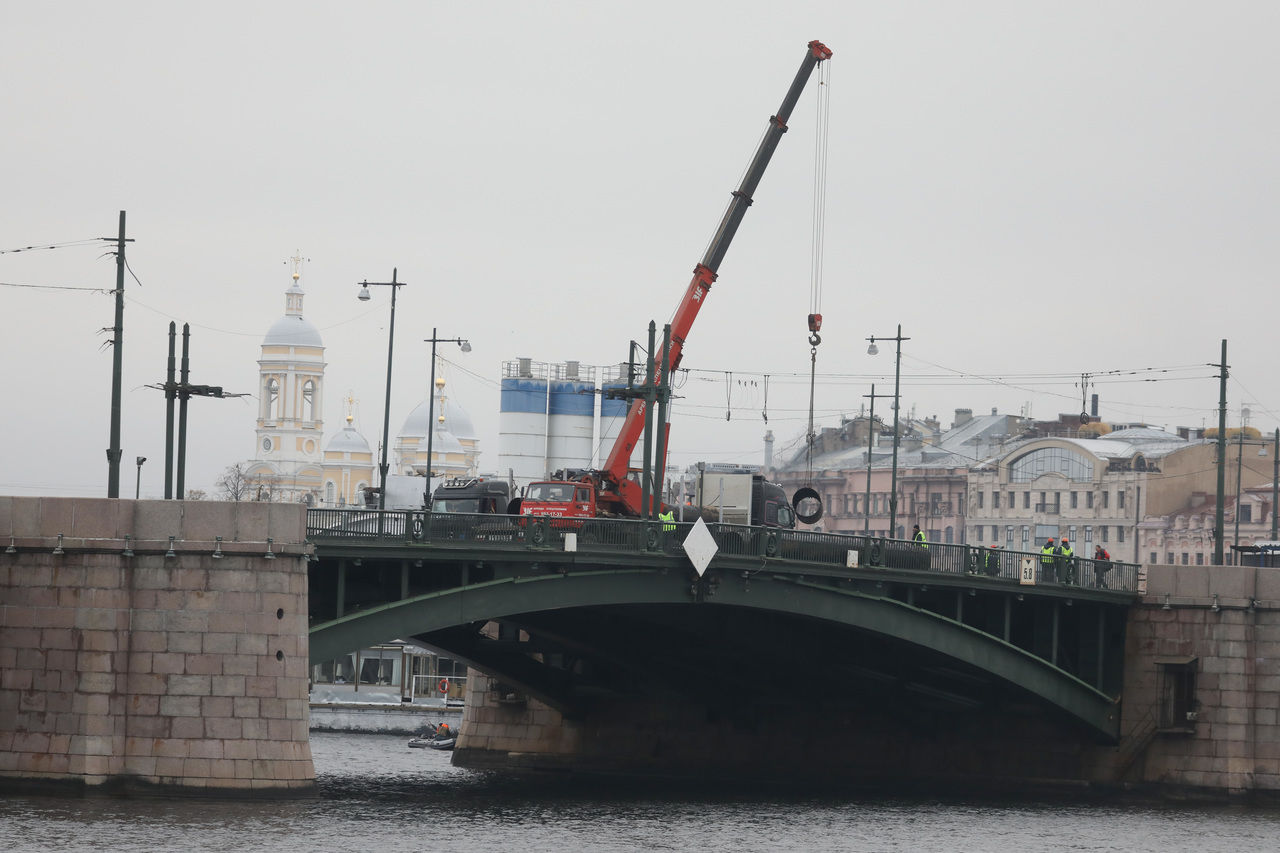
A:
[0,0,1280,496]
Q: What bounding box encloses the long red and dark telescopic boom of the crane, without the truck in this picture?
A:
[602,41,831,515]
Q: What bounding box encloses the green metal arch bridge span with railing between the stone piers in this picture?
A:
[307,510,1138,743]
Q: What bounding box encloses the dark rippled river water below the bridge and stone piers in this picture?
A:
[0,733,1280,853]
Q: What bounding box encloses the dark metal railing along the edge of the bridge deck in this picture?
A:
[307,510,1138,593]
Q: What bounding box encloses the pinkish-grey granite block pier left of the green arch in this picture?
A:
[0,497,315,794]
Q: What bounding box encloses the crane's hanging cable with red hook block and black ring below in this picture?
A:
[791,61,831,524]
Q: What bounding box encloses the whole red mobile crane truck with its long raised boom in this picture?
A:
[520,41,831,517]
